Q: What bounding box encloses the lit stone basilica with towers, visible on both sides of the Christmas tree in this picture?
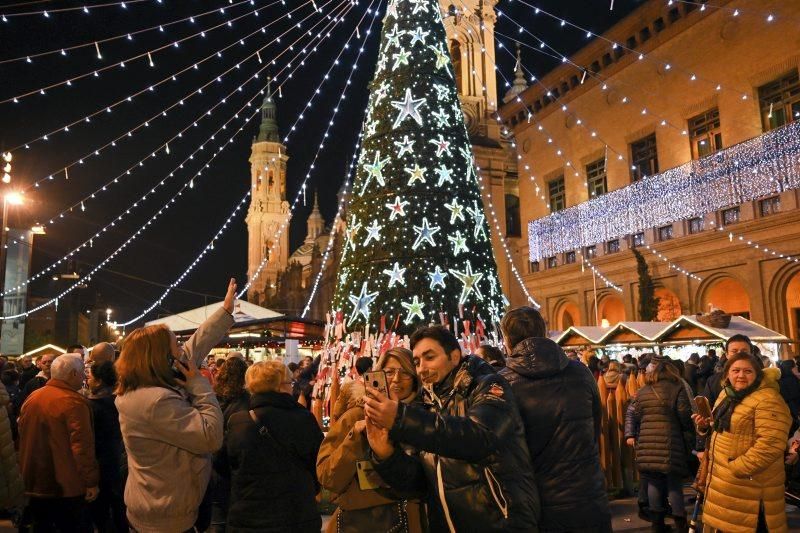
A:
[247,0,527,319]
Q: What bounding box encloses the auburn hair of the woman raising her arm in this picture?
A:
[114,324,176,396]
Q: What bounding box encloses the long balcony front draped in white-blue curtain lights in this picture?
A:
[528,122,800,261]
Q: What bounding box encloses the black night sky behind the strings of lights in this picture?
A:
[0,0,641,321]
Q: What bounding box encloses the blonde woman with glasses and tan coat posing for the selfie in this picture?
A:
[317,348,424,533]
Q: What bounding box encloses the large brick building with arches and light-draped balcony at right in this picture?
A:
[499,0,800,338]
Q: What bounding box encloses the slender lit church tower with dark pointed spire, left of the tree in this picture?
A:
[246,87,289,304]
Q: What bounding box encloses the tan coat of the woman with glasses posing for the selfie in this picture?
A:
[317,382,423,533]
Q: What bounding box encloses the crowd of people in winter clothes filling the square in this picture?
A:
[0,280,800,533]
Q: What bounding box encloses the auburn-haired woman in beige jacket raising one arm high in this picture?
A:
[115,278,236,533]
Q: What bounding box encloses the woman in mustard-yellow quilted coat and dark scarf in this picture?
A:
[693,352,792,533]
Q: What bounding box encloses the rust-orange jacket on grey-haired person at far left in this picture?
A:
[19,379,100,498]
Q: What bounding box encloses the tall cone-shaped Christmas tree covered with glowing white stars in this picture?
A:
[333,0,504,332]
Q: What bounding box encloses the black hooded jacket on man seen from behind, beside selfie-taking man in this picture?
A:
[500,338,611,531]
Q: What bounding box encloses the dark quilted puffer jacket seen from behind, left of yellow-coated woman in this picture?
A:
[625,379,692,476]
